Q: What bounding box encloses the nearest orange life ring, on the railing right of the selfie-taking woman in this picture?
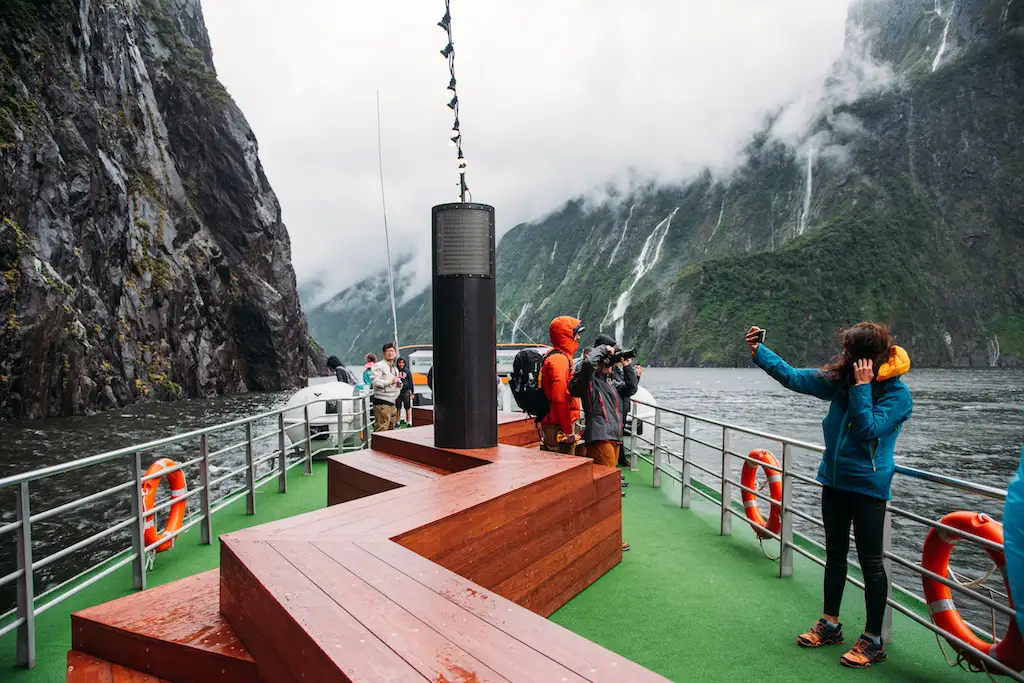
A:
[921,510,1024,671]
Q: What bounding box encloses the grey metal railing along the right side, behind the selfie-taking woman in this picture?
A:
[629,400,1024,681]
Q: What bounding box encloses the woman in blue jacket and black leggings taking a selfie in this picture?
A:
[746,323,913,669]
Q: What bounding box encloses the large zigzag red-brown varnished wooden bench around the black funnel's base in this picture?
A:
[68,416,666,683]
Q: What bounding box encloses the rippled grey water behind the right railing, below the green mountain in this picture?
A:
[643,369,1024,628]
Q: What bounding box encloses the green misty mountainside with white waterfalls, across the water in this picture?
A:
[311,0,1024,366]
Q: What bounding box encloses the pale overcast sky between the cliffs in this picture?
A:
[197,0,848,301]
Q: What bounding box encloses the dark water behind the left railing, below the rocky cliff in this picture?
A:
[0,393,289,612]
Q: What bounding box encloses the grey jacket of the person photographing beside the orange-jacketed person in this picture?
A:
[569,346,639,442]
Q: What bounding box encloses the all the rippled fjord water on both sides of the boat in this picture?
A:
[0,368,1024,626]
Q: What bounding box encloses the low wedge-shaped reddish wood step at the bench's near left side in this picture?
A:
[71,569,257,683]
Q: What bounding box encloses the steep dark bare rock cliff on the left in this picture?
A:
[0,0,309,418]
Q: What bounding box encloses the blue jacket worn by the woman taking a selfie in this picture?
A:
[754,344,913,501]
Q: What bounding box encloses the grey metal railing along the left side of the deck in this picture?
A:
[0,394,371,669]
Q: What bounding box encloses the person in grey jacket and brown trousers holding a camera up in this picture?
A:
[569,344,637,550]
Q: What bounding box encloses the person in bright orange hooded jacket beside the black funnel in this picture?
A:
[541,315,586,455]
